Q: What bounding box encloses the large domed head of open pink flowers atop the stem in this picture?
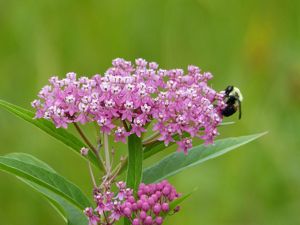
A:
[32,58,225,152]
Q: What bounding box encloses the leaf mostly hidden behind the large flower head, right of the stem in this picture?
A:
[144,122,234,159]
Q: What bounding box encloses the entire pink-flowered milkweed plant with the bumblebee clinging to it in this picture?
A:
[0,58,264,225]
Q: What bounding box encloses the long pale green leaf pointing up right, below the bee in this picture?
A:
[143,132,266,183]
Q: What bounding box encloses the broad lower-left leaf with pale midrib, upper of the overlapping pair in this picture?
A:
[0,153,91,210]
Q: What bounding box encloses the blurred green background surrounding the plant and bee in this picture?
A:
[0,0,300,225]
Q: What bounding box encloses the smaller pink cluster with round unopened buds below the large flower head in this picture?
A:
[84,180,179,225]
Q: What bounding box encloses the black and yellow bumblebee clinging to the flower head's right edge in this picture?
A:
[222,85,243,119]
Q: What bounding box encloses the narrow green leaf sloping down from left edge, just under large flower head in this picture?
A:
[0,100,99,170]
